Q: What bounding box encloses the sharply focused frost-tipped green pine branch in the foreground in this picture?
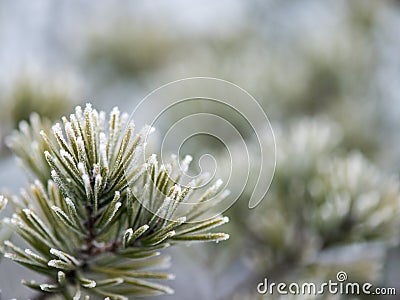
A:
[0,104,229,299]
